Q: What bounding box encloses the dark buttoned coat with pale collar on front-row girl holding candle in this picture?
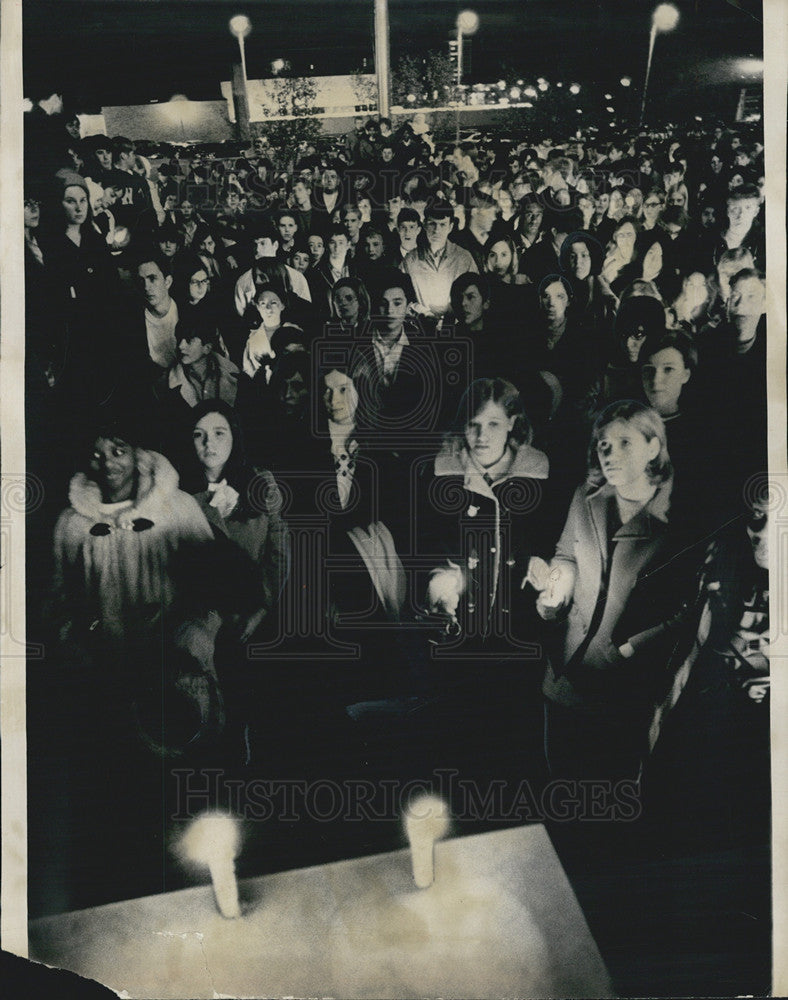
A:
[416,443,549,659]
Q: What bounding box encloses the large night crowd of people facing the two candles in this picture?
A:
[24,99,769,777]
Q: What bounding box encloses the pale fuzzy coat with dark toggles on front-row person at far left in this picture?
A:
[54,450,213,639]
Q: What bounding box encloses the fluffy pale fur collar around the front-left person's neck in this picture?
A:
[68,448,183,530]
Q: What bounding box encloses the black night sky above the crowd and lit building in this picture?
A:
[22,0,762,112]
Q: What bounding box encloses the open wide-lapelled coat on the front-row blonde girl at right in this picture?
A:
[543,482,704,713]
